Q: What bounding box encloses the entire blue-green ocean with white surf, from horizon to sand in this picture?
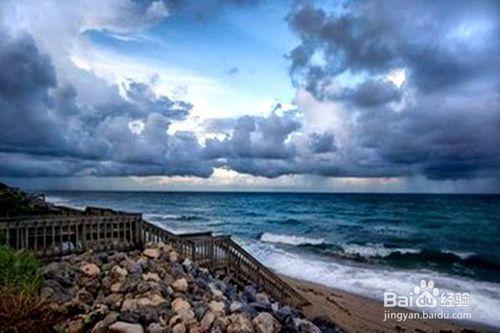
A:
[45,191,500,327]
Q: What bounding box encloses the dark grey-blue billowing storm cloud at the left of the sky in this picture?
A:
[0,36,212,177]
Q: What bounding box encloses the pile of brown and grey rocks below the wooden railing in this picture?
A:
[41,244,336,333]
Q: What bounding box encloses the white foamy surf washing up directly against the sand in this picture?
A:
[245,242,500,327]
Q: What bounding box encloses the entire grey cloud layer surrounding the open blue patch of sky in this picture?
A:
[0,1,500,189]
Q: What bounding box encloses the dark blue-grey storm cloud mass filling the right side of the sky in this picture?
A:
[280,1,500,179]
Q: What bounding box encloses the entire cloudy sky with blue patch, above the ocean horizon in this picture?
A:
[0,0,500,193]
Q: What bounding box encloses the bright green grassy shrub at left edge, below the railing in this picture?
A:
[0,245,42,293]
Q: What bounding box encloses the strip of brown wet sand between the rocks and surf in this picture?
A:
[278,274,499,332]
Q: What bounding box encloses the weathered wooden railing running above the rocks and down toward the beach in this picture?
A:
[0,213,308,306]
